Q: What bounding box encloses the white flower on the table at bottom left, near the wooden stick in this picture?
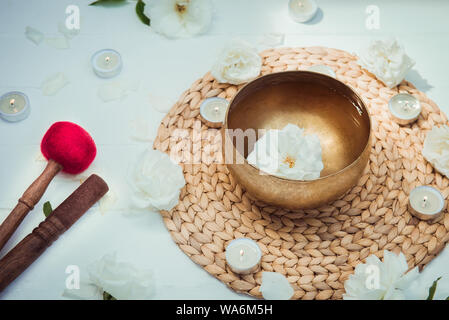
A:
[63,254,154,300]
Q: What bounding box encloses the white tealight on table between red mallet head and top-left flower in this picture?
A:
[91,49,122,78]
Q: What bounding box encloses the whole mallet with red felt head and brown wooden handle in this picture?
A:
[0,121,97,250]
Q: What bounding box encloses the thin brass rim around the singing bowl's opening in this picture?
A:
[223,70,372,184]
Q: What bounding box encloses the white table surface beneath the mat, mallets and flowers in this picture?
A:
[0,0,449,299]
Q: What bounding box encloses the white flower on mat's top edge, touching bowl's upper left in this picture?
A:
[211,39,262,84]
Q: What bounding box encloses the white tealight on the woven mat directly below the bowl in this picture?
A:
[225,238,262,274]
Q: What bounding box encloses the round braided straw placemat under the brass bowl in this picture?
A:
[154,47,449,299]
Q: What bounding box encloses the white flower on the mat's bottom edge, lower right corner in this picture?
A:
[343,250,419,300]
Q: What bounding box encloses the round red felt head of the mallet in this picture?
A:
[41,121,97,174]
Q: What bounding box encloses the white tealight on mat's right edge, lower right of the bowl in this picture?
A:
[409,186,445,222]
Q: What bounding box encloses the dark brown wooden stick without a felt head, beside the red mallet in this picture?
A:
[0,175,108,292]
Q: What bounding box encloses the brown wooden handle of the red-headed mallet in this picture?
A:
[0,160,62,250]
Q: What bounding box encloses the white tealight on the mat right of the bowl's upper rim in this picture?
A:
[388,93,421,125]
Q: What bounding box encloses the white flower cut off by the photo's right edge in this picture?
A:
[422,125,449,177]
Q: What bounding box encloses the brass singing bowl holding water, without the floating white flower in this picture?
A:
[223,71,371,209]
